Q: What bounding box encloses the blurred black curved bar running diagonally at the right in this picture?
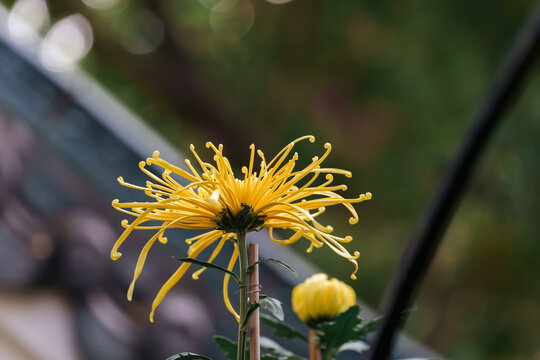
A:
[367,3,540,360]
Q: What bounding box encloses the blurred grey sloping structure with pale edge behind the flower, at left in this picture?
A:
[0,7,431,360]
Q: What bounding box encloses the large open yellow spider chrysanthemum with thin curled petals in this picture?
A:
[111,136,371,322]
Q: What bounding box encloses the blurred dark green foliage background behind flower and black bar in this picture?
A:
[3,0,540,360]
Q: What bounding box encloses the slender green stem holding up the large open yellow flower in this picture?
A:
[236,232,249,360]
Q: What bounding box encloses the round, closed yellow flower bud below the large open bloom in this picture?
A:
[292,273,356,327]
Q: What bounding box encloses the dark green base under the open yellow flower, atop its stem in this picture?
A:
[216,204,266,233]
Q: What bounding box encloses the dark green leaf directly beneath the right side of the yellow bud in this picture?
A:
[316,305,362,350]
